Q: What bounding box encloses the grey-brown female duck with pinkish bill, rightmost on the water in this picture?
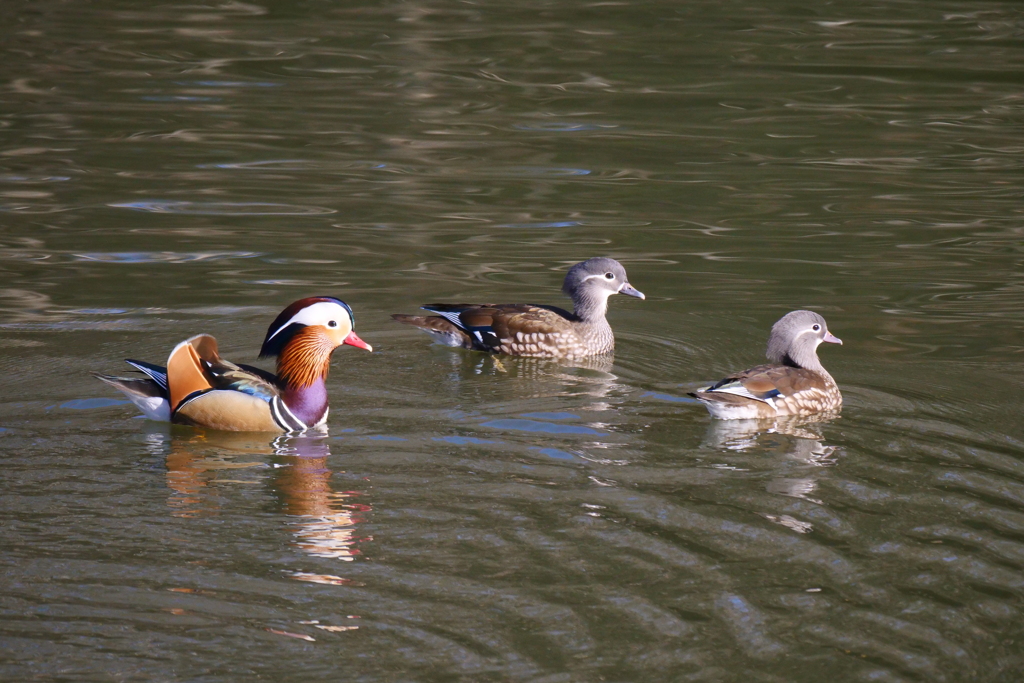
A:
[690,310,843,420]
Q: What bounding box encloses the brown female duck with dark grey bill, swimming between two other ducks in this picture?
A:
[391,258,645,359]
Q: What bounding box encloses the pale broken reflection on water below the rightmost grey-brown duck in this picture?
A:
[705,414,839,507]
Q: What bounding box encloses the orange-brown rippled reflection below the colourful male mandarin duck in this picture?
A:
[159,429,371,561]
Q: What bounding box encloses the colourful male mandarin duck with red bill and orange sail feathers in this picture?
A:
[93,297,373,432]
